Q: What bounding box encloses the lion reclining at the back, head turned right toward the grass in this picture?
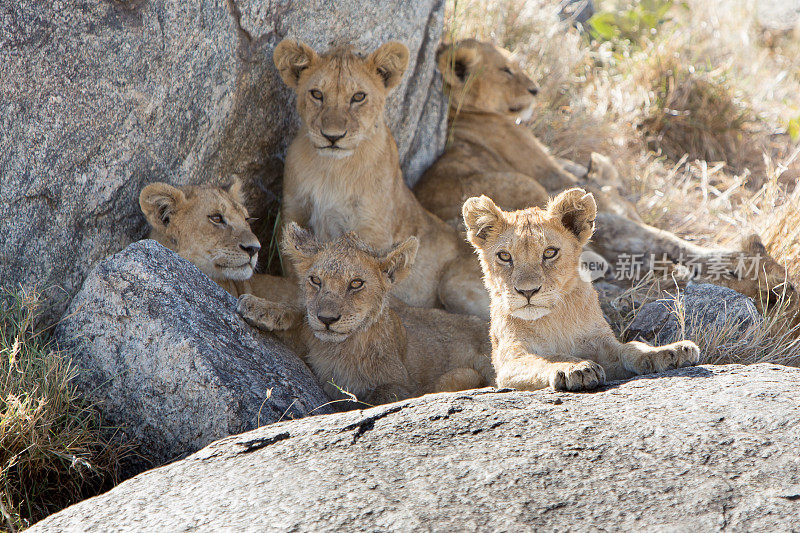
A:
[414,39,794,308]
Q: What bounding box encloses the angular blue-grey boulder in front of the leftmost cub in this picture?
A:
[55,241,330,469]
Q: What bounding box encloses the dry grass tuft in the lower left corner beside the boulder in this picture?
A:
[0,290,127,531]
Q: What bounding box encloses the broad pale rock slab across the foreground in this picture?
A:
[30,364,800,532]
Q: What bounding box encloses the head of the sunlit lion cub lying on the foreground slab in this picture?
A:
[463,189,597,320]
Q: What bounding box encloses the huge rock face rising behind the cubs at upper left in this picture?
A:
[0,0,446,313]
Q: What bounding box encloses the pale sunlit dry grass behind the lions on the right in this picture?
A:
[447,0,800,363]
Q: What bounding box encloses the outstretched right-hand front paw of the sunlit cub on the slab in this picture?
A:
[617,341,700,375]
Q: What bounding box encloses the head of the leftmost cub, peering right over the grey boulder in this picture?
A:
[139,182,261,281]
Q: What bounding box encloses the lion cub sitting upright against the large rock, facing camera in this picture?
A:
[274,40,489,317]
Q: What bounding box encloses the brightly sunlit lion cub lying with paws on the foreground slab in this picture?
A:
[462,188,700,391]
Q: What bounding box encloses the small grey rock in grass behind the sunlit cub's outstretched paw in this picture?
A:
[626,283,763,344]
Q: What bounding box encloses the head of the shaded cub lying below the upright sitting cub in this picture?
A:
[282,222,419,342]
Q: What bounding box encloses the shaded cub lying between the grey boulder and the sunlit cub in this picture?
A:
[239,223,494,405]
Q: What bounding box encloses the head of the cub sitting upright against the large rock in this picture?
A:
[273,39,408,157]
